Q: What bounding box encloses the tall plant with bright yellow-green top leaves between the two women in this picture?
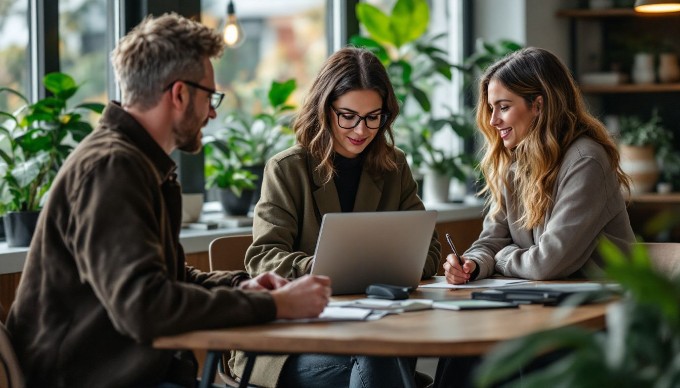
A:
[350,0,520,181]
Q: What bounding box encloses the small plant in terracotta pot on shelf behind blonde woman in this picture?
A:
[618,110,677,194]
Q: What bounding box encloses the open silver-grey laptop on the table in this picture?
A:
[311,210,437,295]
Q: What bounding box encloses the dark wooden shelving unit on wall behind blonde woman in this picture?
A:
[556,8,680,241]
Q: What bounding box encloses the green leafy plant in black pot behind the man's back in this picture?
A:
[0,73,104,246]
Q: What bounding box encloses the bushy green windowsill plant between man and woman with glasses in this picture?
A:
[203,79,296,214]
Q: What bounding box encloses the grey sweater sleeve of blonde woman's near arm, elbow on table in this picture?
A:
[495,152,621,280]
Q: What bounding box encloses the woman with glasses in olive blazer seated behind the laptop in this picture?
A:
[232,48,441,387]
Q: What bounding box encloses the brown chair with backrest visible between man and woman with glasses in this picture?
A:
[208,234,253,387]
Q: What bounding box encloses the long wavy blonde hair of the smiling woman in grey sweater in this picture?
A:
[476,47,630,229]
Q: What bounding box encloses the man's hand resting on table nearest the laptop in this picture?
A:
[271,275,331,319]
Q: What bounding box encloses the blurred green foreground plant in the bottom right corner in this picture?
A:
[476,240,680,387]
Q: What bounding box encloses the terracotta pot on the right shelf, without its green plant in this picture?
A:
[619,145,659,194]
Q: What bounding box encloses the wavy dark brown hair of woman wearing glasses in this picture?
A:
[293,47,399,183]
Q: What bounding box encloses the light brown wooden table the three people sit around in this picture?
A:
[153,289,606,383]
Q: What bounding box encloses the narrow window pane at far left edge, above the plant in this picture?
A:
[0,0,29,112]
